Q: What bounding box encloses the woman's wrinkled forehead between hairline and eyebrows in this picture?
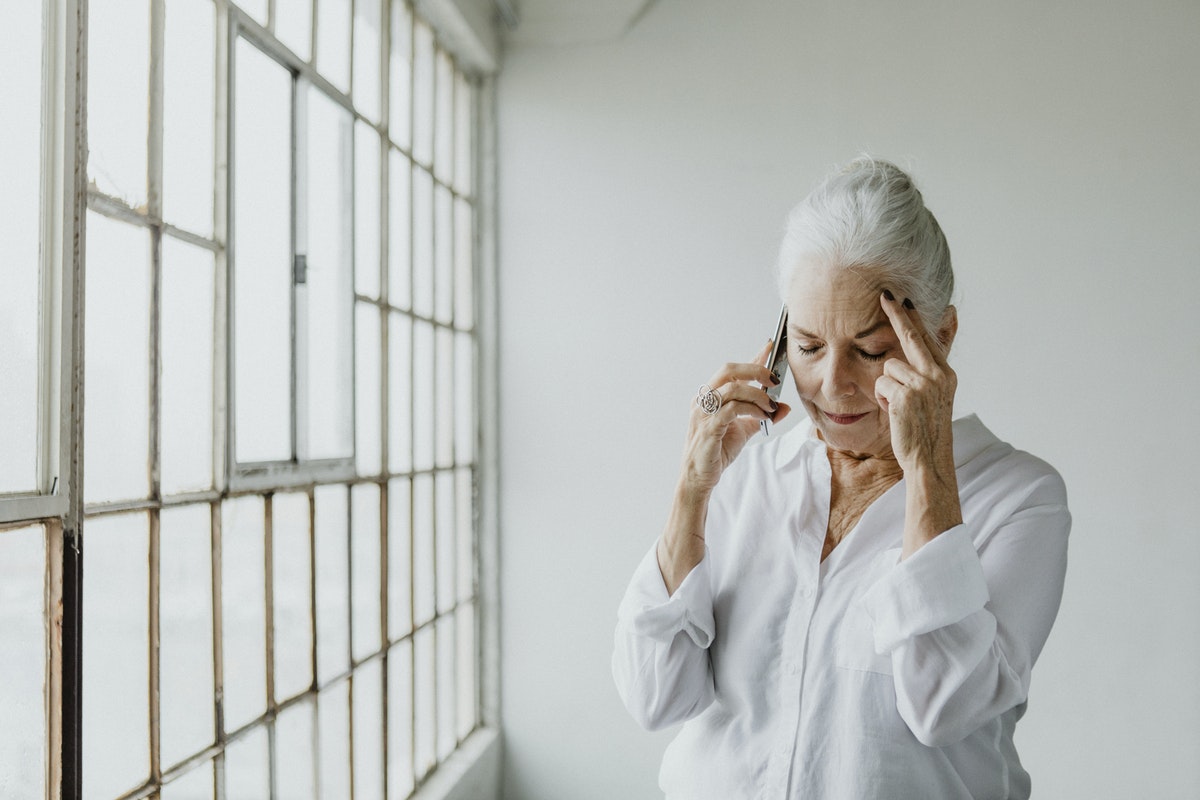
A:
[786,263,887,338]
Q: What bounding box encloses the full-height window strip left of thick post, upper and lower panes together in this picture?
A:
[0,1,76,796]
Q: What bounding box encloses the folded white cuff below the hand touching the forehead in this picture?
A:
[860,525,989,655]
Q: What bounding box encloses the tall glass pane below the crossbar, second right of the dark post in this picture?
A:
[158,503,214,767]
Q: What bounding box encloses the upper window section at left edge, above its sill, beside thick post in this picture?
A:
[0,2,71,524]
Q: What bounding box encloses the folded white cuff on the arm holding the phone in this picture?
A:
[622,547,716,648]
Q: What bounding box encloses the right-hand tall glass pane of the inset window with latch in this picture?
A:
[296,85,354,458]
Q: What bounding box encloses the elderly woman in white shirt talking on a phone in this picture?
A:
[613,158,1070,800]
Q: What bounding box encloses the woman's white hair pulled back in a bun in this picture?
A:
[776,156,954,331]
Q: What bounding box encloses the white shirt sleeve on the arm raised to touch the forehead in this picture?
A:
[860,475,1070,747]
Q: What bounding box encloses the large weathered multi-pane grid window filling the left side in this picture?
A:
[0,0,481,800]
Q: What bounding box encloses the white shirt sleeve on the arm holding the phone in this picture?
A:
[612,548,716,730]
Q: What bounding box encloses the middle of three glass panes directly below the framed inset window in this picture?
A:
[271,493,312,700]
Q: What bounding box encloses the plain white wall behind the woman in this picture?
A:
[498,0,1200,800]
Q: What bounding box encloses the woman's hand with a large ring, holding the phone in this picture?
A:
[680,342,791,497]
